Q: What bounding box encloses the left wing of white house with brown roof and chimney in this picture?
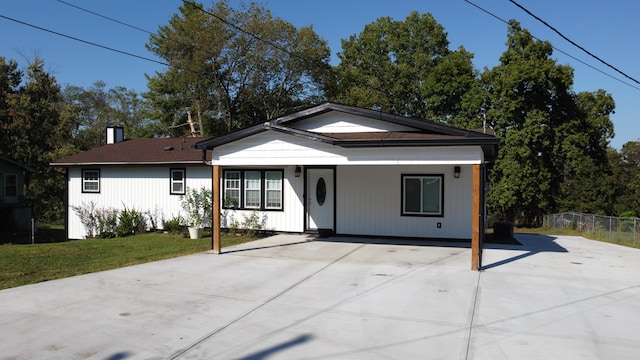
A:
[51,127,211,239]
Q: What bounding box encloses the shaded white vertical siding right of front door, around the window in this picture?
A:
[336,165,473,239]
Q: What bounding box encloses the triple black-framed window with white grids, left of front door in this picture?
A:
[222,169,284,210]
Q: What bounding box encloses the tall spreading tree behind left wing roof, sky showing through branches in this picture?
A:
[144,0,330,135]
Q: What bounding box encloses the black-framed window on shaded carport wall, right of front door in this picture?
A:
[402,174,444,216]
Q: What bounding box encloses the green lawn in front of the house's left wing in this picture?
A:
[0,233,253,289]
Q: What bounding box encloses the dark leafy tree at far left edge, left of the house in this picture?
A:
[0,57,74,221]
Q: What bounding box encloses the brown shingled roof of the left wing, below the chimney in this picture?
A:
[51,138,211,166]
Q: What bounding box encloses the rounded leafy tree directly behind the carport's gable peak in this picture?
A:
[328,11,477,122]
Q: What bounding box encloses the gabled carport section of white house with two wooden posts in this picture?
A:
[195,102,498,269]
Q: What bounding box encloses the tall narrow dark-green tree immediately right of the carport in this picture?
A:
[482,21,574,225]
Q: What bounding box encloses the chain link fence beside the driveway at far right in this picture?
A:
[544,212,640,247]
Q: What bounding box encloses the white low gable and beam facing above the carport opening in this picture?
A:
[213,131,483,166]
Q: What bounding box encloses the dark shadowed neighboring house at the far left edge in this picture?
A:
[0,155,34,231]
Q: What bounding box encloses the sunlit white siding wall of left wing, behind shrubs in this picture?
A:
[67,166,211,239]
